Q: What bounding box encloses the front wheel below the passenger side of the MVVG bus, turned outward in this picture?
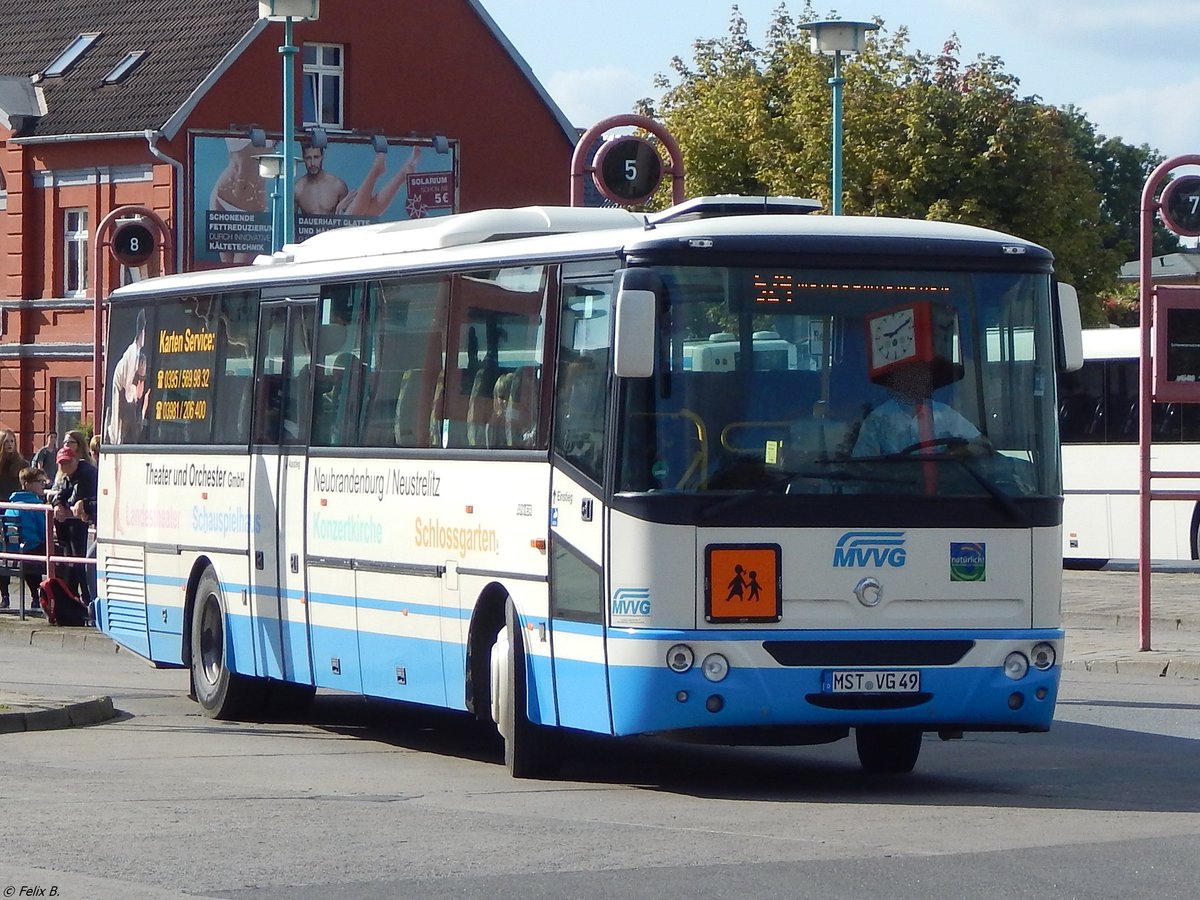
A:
[491,602,558,778]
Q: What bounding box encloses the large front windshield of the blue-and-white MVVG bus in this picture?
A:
[617,265,1060,500]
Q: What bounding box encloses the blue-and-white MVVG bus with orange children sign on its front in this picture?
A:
[97,198,1078,778]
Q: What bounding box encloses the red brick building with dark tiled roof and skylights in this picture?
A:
[0,0,577,456]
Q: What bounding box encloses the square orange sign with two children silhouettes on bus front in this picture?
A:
[704,544,784,622]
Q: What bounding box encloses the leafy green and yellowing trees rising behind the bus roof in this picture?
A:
[641,2,1160,320]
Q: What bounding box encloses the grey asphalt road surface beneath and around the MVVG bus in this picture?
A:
[0,643,1200,900]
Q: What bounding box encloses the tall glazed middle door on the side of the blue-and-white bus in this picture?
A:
[250,300,316,684]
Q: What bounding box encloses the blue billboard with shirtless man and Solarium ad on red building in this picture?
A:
[192,133,457,268]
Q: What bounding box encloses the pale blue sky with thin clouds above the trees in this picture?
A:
[480,0,1200,157]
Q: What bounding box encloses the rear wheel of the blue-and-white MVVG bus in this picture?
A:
[192,568,266,719]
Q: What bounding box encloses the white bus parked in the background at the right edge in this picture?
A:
[1058,328,1200,569]
